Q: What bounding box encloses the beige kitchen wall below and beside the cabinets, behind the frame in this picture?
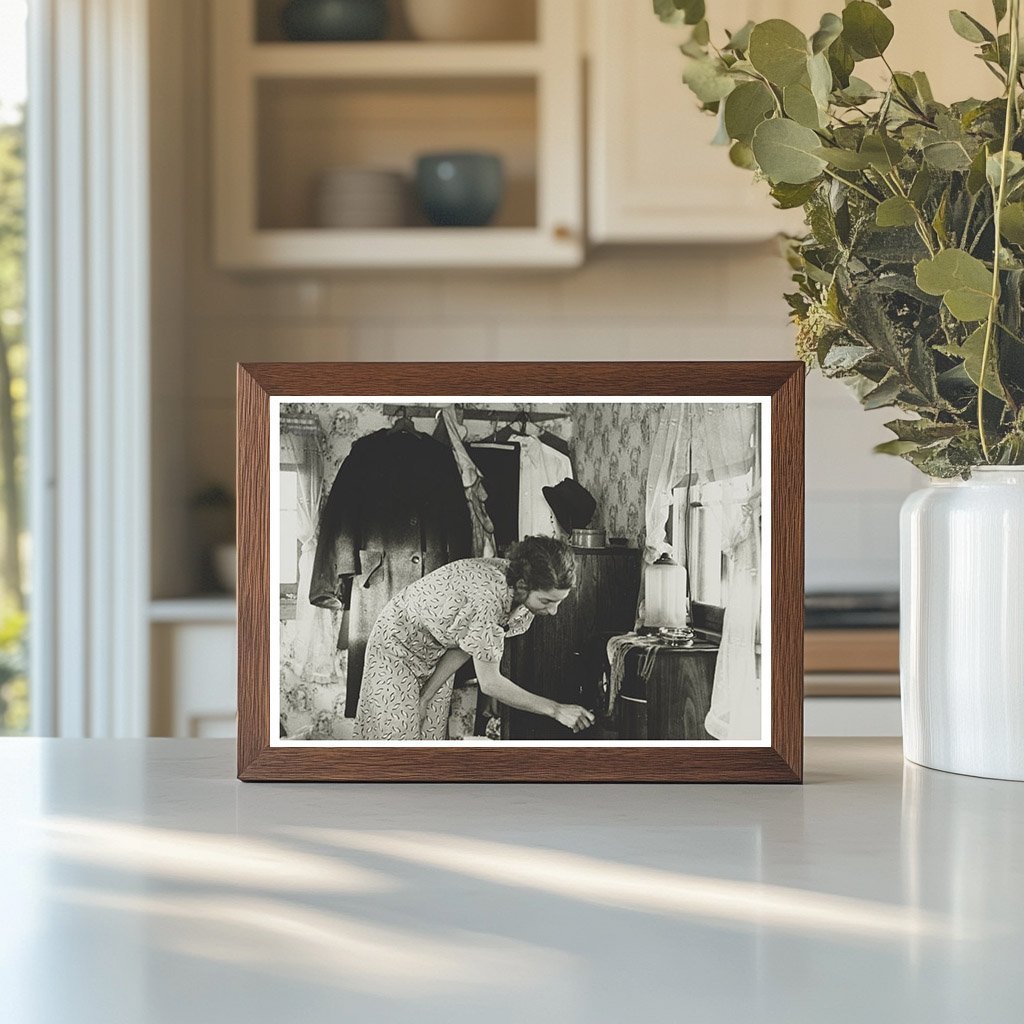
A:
[155,0,918,589]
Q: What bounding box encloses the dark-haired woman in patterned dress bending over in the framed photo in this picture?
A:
[353,537,594,739]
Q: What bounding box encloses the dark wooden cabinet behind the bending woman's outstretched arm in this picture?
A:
[503,548,641,739]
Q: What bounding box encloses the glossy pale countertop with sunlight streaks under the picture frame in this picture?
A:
[0,739,1024,1024]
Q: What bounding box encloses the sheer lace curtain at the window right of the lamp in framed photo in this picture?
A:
[644,403,761,740]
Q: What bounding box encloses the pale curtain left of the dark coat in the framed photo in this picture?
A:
[281,431,340,682]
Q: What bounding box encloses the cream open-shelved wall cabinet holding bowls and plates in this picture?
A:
[211,0,584,269]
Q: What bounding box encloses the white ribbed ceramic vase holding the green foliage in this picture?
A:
[900,466,1024,781]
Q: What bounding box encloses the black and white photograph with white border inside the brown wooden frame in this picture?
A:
[270,395,771,746]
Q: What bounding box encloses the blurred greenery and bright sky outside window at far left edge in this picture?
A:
[0,0,30,735]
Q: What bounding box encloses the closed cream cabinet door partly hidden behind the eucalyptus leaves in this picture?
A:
[587,0,997,244]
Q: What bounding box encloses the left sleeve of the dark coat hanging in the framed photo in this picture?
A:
[309,442,364,608]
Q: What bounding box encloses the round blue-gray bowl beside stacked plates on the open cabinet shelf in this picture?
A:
[416,153,505,227]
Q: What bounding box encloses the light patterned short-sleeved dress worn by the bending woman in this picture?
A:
[352,558,534,739]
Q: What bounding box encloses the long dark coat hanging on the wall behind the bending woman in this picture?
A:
[309,429,473,718]
